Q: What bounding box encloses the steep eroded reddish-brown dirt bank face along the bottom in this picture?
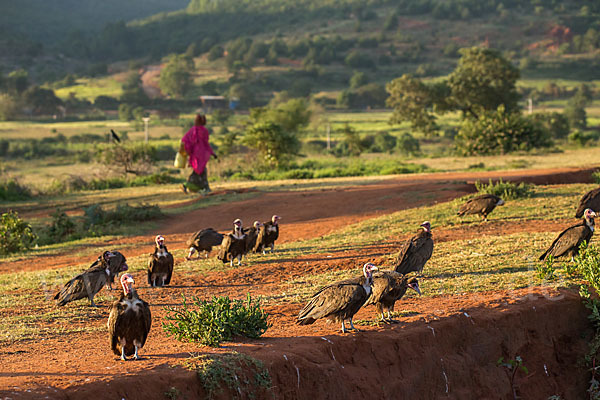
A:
[50,291,592,400]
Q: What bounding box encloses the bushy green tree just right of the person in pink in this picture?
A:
[244,121,300,168]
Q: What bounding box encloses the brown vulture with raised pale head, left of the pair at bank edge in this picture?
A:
[296,263,377,333]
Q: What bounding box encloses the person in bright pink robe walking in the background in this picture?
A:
[180,114,217,193]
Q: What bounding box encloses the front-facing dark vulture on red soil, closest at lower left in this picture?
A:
[108,274,152,361]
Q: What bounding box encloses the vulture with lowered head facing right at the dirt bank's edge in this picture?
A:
[367,271,421,324]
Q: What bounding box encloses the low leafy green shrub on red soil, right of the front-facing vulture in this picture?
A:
[162,294,271,347]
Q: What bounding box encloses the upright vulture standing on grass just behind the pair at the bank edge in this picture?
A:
[394,221,433,275]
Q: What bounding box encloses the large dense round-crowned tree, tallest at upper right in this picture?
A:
[448,47,519,118]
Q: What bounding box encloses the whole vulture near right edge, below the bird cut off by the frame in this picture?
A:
[540,208,596,261]
